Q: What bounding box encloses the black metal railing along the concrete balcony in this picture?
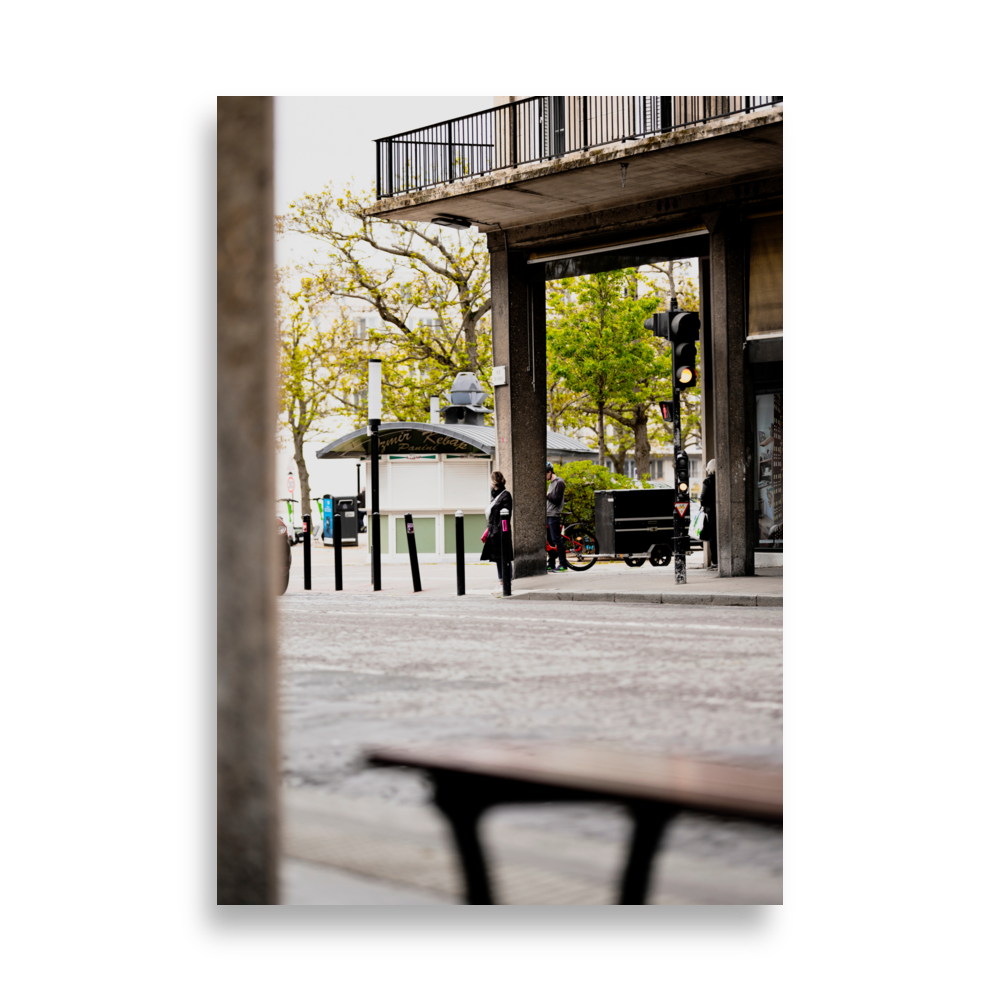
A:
[375,96,784,198]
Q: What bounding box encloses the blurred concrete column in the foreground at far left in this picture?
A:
[216,97,278,905]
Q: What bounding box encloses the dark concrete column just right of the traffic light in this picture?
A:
[705,212,755,577]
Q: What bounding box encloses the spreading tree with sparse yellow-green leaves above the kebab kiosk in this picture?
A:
[276,187,493,420]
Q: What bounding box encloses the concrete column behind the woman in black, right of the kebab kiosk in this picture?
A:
[490,250,546,579]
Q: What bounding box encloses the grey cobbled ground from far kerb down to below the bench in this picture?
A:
[279,592,783,903]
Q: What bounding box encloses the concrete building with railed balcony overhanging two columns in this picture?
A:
[372,96,784,577]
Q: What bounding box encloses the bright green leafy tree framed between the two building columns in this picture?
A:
[547,268,662,472]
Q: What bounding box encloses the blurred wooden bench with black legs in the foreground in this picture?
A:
[366,742,782,905]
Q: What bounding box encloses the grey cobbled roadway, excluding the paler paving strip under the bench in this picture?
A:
[279,592,783,893]
